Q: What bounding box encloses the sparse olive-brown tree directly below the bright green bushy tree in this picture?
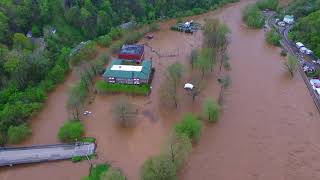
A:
[165,133,192,169]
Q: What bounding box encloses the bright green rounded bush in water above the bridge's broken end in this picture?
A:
[58,120,84,142]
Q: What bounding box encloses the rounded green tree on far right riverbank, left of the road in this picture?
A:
[242,5,265,29]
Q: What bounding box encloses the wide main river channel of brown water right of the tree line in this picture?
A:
[180,2,320,180]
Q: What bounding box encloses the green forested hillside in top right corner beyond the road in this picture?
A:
[287,0,320,57]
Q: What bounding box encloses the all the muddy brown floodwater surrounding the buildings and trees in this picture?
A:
[0,1,320,180]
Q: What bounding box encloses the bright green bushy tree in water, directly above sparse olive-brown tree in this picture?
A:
[175,114,202,142]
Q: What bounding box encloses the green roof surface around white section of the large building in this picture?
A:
[103,60,152,79]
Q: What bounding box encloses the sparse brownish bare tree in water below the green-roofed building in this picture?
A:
[112,98,137,127]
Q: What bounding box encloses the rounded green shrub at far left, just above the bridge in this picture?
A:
[8,123,31,144]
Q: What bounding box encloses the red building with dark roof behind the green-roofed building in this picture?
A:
[118,44,144,63]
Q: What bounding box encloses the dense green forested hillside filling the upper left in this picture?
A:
[0,0,235,144]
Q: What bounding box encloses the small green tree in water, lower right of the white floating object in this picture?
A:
[202,98,220,123]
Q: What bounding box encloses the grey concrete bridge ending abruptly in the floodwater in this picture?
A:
[0,143,96,166]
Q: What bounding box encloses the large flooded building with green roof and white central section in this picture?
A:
[103,60,152,84]
